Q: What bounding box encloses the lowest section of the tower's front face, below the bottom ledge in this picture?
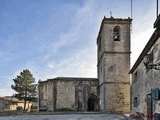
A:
[105,83,130,113]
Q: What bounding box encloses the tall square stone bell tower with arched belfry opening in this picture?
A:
[97,17,132,113]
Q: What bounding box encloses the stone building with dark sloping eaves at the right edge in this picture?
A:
[129,16,160,115]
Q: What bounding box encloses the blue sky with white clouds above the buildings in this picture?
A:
[0,0,156,96]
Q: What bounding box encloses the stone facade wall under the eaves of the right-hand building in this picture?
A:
[132,38,160,115]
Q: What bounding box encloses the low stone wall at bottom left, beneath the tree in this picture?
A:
[0,110,22,116]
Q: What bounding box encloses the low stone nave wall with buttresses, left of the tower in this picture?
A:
[38,77,99,111]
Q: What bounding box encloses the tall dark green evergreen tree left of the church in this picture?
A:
[11,69,37,110]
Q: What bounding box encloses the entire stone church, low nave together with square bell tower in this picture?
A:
[38,17,132,113]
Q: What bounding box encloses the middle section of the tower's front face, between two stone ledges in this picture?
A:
[104,53,130,83]
